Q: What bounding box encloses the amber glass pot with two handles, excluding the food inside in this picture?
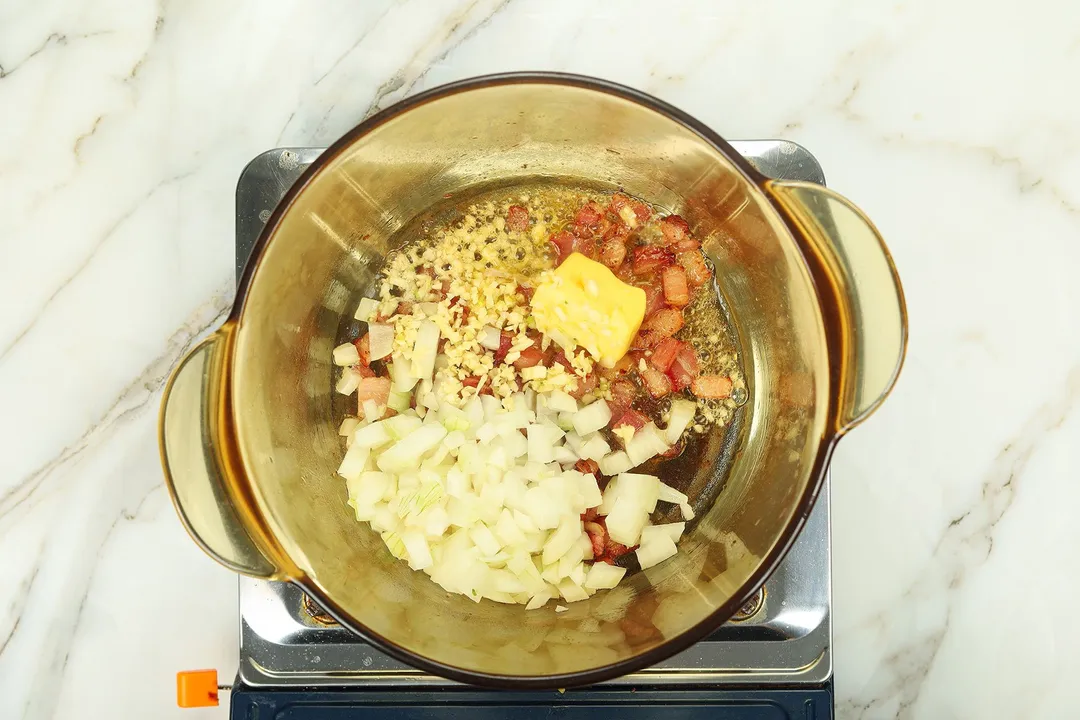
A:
[160,73,906,688]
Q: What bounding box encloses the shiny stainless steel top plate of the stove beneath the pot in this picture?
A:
[237,140,833,687]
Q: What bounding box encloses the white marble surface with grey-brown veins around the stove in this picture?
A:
[0,0,1080,719]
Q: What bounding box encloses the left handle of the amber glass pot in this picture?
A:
[158,326,282,580]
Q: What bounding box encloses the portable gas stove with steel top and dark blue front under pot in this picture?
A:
[230,140,833,720]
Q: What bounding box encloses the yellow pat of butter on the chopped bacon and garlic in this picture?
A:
[532,253,645,367]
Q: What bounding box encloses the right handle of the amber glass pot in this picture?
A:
[766,180,907,432]
